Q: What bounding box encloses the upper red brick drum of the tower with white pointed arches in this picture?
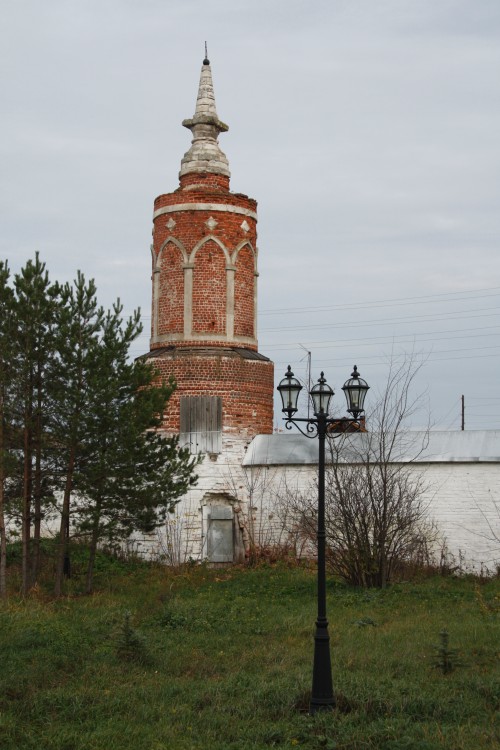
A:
[151,184,257,350]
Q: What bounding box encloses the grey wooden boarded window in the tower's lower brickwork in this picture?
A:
[179,396,222,453]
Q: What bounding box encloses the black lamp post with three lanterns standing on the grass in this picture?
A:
[278,365,370,714]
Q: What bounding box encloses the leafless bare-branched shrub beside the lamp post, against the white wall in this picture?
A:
[286,356,432,588]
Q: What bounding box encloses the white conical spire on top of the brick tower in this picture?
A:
[179,55,231,177]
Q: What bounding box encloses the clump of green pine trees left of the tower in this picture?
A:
[0,254,198,595]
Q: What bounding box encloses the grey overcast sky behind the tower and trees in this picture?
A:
[0,0,500,429]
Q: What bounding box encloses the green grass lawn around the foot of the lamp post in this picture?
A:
[0,556,500,750]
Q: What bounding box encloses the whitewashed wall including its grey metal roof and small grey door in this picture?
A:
[136,430,500,571]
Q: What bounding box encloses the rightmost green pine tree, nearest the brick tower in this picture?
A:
[70,303,197,592]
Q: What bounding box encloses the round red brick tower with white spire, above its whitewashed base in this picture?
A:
[148,54,274,453]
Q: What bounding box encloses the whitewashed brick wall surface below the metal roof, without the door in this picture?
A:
[139,458,500,571]
